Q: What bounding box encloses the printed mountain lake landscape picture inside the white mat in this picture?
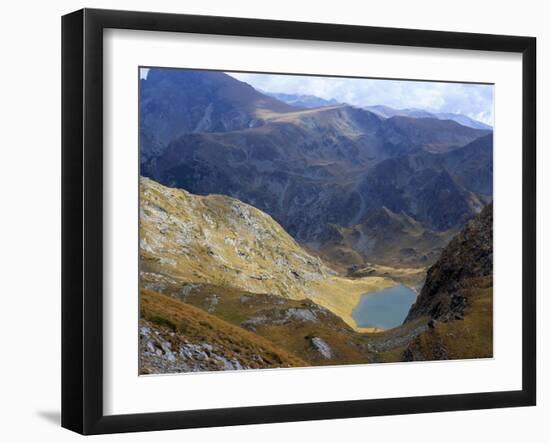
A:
[136,67,493,375]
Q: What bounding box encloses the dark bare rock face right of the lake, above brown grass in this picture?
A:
[406,203,493,321]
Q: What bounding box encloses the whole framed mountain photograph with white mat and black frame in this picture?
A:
[62,9,536,434]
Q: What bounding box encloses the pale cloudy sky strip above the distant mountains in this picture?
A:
[228,72,493,125]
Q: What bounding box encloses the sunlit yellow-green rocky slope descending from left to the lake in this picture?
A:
[140,178,395,328]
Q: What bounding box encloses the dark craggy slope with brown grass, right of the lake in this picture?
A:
[403,204,493,360]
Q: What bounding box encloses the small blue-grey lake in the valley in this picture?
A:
[352,285,416,329]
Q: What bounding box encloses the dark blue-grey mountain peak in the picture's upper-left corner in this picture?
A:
[139,68,294,160]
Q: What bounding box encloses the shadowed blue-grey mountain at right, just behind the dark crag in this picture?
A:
[357,136,493,231]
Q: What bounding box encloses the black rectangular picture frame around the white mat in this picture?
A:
[62,9,536,434]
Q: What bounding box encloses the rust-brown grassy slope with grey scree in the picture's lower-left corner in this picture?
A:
[140,289,306,374]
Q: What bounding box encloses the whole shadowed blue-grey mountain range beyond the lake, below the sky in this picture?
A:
[140,69,493,266]
